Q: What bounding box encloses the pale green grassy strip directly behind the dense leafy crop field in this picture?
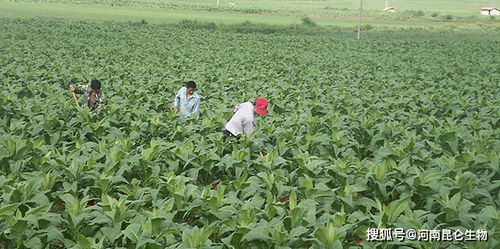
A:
[0,0,500,29]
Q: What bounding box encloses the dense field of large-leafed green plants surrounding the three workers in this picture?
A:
[0,19,500,249]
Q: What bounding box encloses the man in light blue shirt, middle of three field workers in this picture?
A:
[172,81,201,119]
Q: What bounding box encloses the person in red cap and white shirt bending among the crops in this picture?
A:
[224,98,268,141]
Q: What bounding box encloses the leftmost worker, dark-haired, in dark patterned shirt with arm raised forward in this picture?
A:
[69,79,105,111]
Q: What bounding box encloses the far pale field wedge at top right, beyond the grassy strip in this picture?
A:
[9,0,500,22]
